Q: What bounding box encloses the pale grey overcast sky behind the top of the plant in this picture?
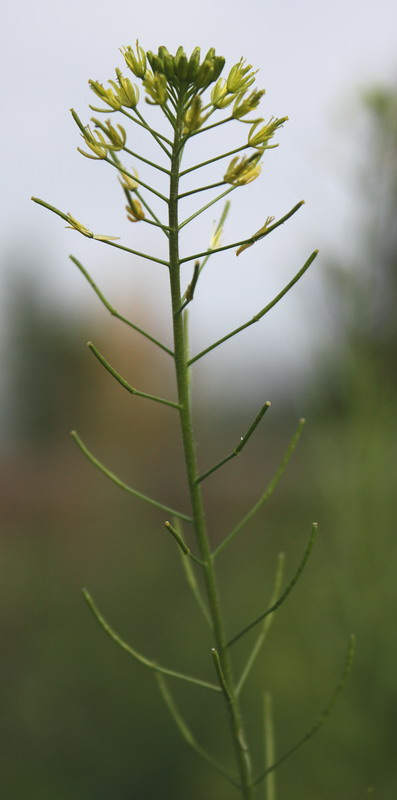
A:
[0,0,397,398]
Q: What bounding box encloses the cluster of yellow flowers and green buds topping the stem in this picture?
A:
[72,40,288,199]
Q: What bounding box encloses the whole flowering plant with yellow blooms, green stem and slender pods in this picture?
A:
[32,41,351,800]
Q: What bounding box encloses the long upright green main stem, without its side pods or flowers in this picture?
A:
[168,102,254,800]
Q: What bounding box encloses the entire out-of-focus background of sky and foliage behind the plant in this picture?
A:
[0,0,397,800]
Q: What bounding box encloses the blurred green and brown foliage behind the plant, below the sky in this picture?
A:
[0,91,397,800]
